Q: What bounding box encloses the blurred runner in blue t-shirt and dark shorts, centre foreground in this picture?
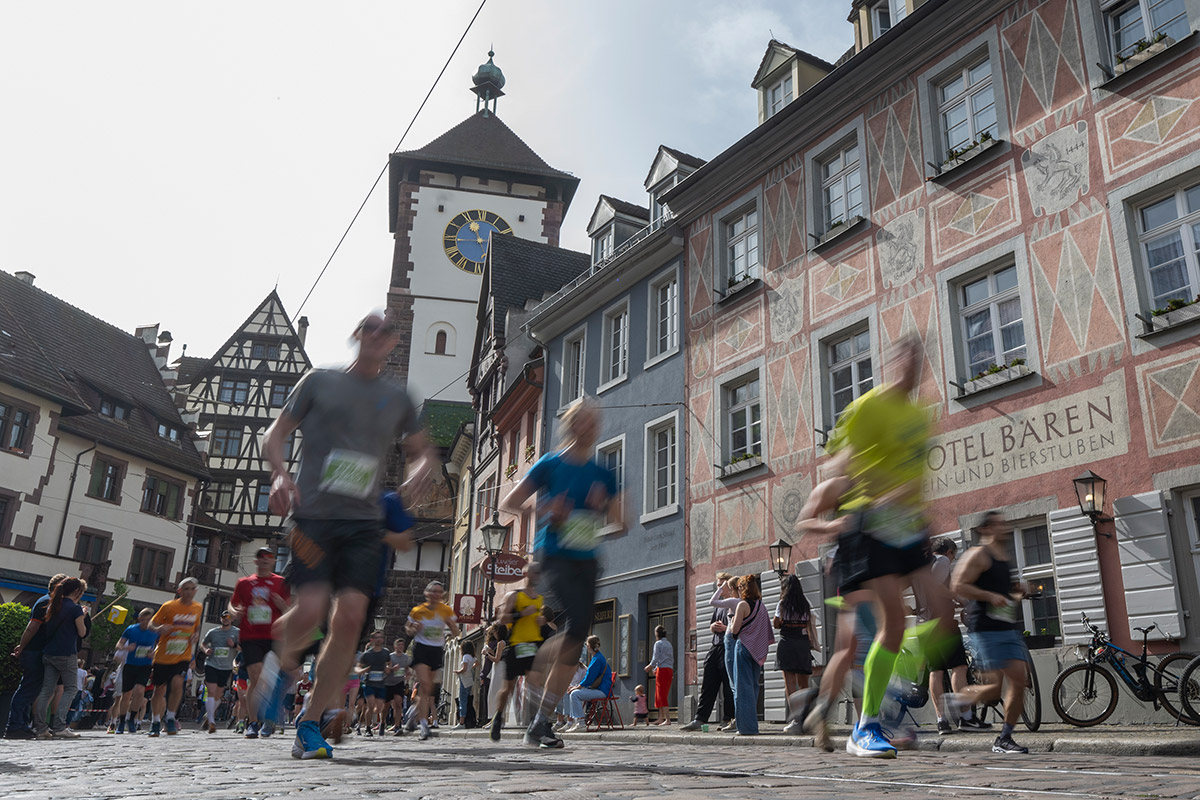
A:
[502,399,625,750]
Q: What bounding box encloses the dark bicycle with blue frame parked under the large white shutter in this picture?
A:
[1050,614,1200,728]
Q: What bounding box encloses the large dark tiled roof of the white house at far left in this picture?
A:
[0,271,208,476]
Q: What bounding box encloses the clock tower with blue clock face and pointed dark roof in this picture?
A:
[388,53,578,403]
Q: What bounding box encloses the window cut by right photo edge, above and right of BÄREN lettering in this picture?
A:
[1138,184,1200,308]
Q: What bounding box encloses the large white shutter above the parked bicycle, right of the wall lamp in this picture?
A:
[1112,492,1183,642]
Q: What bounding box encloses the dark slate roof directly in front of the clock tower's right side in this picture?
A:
[487,236,592,337]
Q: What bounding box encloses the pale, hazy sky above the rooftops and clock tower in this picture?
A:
[0,0,852,366]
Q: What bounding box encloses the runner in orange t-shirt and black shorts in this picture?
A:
[150,578,204,736]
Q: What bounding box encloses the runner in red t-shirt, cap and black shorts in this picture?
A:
[229,547,292,739]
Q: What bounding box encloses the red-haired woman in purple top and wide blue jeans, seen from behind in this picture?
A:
[725,575,775,736]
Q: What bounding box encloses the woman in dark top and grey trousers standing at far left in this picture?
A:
[34,578,89,739]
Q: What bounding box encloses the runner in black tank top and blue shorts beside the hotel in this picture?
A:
[944,511,1030,753]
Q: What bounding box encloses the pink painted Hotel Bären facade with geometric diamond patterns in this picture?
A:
[665,0,1200,717]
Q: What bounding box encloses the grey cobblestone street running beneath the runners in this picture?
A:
[0,730,1200,800]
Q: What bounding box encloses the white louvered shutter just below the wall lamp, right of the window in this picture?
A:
[1050,509,1108,644]
